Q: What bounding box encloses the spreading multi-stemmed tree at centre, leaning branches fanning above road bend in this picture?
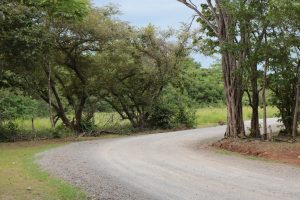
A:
[95,26,190,129]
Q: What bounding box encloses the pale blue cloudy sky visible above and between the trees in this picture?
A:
[93,0,214,67]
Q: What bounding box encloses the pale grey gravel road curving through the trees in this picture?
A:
[37,119,300,200]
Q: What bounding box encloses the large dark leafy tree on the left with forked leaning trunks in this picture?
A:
[0,1,121,133]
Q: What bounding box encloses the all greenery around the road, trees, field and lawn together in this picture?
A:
[0,0,300,199]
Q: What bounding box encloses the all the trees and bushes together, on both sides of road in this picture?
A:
[0,0,300,141]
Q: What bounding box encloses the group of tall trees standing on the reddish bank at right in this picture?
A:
[178,0,300,139]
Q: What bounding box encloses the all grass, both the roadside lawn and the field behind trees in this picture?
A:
[0,107,277,200]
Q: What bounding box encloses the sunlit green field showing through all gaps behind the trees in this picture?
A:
[16,107,277,131]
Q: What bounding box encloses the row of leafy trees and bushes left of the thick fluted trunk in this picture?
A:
[0,0,223,141]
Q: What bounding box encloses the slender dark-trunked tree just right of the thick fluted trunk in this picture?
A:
[239,1,269,138]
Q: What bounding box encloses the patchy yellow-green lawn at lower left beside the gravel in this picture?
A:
[0,142,86,200]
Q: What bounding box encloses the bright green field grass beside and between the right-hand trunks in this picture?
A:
[196,107,277,127]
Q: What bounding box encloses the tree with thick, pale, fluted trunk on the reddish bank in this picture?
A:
[178,0,253,137]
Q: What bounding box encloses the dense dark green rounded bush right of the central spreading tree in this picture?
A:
[150,86,196,129]
